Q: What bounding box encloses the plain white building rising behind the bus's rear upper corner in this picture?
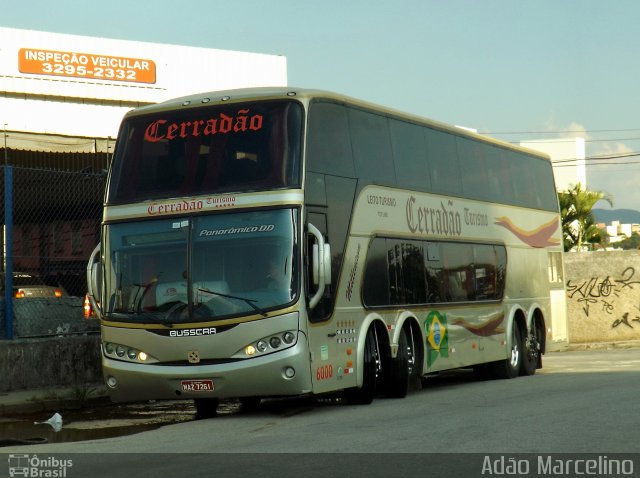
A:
[520,138,587,191]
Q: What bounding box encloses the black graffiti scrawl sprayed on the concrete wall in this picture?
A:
[567,267,640,328]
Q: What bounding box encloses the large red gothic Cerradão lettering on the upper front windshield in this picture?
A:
[144,109,263,143]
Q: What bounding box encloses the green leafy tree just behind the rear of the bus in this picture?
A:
[558,183,613,252]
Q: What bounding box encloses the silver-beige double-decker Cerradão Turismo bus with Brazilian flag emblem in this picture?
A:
[87,88,563,416]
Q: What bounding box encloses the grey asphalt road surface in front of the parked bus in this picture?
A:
[0,349,640,478]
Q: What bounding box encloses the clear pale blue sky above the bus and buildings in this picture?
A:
[0,0,640,210]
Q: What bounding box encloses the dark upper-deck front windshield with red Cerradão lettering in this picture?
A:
[107,101,302,204]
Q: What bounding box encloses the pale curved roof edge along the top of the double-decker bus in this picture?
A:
[125,86,550,161]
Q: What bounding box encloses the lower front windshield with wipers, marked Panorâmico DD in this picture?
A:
[104,208,299,326]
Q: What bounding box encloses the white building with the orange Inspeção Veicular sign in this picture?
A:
[0,28,287,152]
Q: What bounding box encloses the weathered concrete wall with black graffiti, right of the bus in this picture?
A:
[564,251,640,344]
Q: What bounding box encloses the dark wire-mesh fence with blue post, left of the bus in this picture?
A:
[0,165,106,338]
